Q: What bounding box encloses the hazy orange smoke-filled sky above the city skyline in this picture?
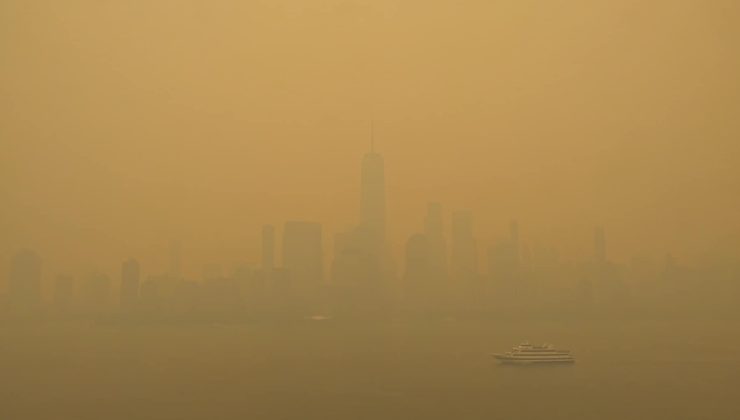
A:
[0,0,740,275]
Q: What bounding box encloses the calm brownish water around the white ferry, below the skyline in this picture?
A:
[0,321,740,420]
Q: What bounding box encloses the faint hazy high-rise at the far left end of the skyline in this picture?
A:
[8,250,41,308]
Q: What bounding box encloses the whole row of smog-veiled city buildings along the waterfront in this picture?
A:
[0,146,740,318]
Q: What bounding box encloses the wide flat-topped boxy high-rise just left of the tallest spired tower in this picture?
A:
[283,222,324,294]
